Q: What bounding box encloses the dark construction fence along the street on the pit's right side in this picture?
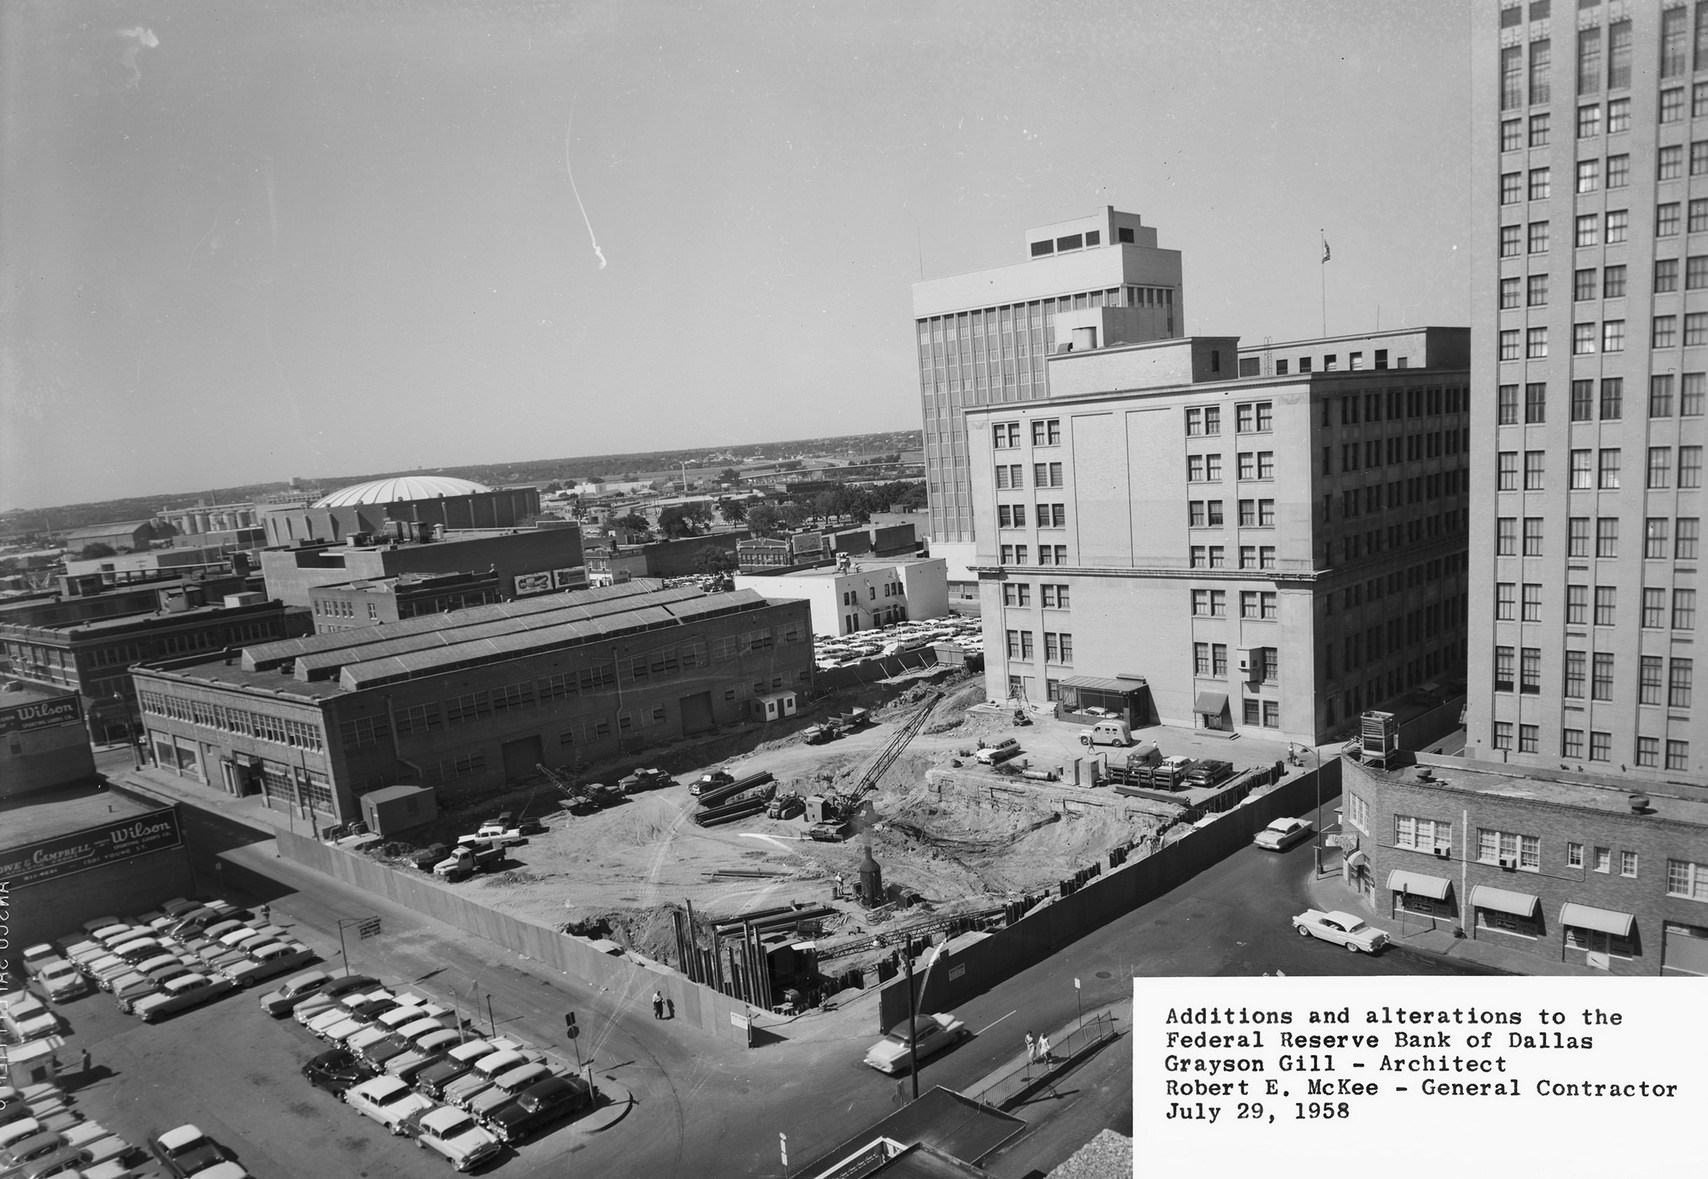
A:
[878,760,1341,1032]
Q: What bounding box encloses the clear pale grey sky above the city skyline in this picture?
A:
[0,0,1471,507]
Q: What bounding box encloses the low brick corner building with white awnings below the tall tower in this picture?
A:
[1342,757,1708,976]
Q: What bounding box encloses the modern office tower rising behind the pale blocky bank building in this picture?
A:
[914,207,1185,603]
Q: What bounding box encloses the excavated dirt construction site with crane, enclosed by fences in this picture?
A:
[367,672,1284,1010]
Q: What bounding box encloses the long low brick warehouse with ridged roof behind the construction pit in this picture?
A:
[133,581,813,822]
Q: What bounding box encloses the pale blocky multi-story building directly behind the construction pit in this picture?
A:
[967,328,1469,743]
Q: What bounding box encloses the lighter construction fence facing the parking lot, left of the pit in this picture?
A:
[278,830,748,1044]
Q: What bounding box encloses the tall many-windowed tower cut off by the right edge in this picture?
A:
[1465,0,1708,783]
